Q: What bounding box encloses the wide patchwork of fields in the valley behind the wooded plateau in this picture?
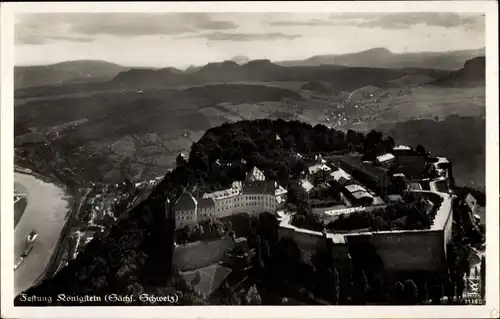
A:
[15,71,485,189]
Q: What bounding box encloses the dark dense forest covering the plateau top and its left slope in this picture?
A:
[15,119,484,306]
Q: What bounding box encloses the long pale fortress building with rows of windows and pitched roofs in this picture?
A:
[174,167,287,228]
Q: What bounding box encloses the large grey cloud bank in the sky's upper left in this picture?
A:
[15,13,238,44]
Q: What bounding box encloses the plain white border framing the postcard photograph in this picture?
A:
[0,1,500,318]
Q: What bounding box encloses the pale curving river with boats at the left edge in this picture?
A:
[14,172,71,295]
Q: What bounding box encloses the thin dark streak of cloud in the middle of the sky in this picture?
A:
[182,31,301,41]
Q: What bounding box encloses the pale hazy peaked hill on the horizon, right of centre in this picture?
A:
[276,48,485,70]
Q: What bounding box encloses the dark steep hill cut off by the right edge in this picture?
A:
[430,56,486,87]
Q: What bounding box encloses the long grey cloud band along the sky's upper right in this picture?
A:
[270,12,485,31]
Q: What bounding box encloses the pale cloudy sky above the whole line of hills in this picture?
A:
[14,12,485,68]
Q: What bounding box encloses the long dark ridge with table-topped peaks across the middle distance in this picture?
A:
[15,55,449,98]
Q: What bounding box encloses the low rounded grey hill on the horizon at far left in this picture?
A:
[14,60,127,89]
